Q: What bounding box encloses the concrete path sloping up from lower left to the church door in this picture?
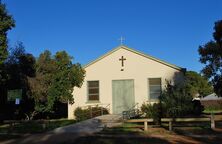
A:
[0,115,121,144]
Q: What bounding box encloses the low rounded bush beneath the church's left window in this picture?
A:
[74,106,109,121]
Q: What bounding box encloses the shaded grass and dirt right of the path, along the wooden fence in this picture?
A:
[70,123,222,144]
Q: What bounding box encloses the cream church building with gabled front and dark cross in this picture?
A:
[68,45,185,119]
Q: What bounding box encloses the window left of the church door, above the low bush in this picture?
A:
[87,81,99,101]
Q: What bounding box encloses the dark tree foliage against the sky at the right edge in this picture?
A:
[198,20,222,96]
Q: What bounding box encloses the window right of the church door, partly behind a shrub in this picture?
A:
[149,78,161,100]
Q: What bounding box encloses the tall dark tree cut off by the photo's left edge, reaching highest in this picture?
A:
[0,3,15,83]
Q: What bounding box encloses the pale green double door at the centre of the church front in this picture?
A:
[112,80,135,114]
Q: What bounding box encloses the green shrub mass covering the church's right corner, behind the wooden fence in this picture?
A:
[141,71,208,119]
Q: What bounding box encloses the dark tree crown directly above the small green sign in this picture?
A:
[5,42,35,95]
